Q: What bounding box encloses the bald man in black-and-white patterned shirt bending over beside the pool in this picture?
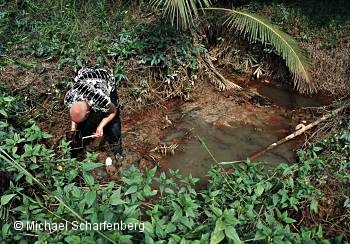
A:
[64,67,123,164]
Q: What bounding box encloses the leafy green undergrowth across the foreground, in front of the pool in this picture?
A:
[0,82,350,243]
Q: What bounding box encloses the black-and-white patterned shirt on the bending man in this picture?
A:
[64,67,119,113]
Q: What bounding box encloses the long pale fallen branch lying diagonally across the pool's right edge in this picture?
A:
[249,104,349,160]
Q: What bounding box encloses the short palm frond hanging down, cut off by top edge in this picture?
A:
[151,0,211,29]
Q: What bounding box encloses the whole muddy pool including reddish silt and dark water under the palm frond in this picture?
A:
[162,82,326,179]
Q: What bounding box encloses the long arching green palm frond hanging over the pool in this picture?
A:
[207,8,316,93]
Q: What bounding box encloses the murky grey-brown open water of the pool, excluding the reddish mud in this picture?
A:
[163,113,295,178]
